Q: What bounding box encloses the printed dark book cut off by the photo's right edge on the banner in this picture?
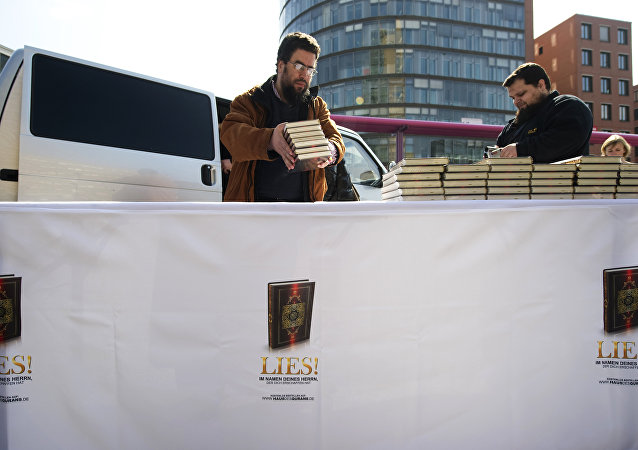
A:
[603,266,638,332]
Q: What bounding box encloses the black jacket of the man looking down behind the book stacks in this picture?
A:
[496,91,593,163]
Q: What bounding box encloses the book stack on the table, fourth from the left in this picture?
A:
[531,164,576,199]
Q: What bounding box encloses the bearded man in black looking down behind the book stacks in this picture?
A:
[496,63,593,163]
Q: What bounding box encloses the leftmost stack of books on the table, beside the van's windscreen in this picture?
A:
[381,157,449,201]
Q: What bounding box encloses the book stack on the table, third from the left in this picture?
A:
[479,156,532,200]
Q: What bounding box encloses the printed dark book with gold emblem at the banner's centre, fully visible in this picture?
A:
[268,280,315,348]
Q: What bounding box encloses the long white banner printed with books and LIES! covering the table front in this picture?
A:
[0,200,638,449]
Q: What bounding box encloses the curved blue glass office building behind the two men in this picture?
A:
[280,0,533,162]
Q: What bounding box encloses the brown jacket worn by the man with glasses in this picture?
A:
[220,78,345,202]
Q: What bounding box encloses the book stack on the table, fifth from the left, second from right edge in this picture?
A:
[574,156,621,198]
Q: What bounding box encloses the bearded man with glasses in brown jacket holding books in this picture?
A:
[221,32,345,202]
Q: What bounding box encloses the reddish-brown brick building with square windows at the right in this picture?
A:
[534,14,638,161]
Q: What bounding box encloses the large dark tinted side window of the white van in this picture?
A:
[30,54,214,160]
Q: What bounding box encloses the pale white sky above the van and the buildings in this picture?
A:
[0,0,638,98]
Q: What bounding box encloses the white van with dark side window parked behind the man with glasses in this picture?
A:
[0,47,385,202]
